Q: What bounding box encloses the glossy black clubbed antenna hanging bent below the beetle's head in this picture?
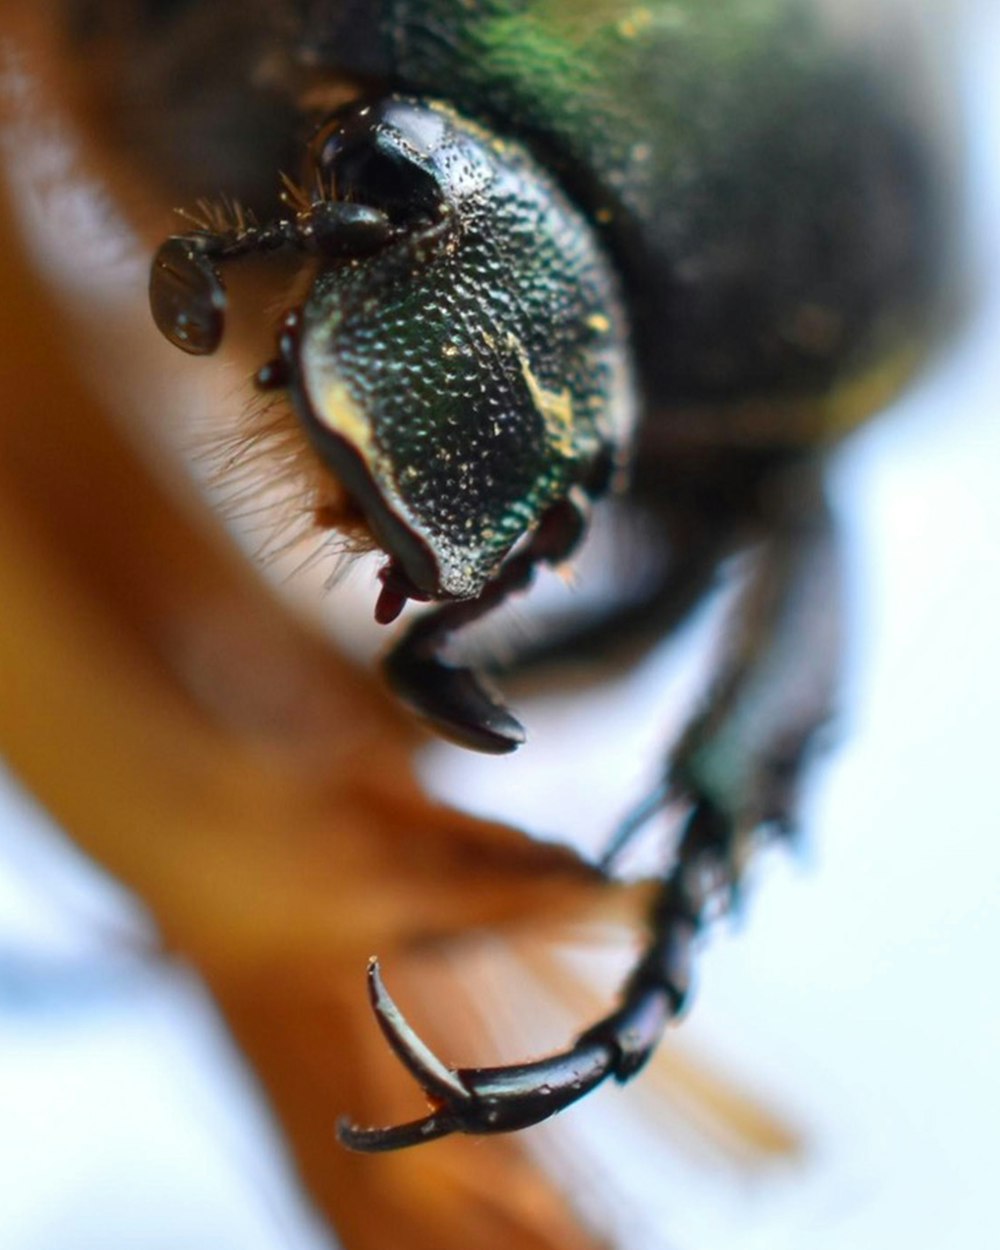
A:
[384,491,586,755]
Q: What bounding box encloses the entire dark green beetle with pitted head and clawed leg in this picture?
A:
[150,0,949,1150]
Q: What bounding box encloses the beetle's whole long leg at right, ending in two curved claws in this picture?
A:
[339,473,839,1150]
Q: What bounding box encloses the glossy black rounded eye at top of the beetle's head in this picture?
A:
[311,108,444,228]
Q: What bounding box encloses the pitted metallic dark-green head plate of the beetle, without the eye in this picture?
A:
[292,101,631,598]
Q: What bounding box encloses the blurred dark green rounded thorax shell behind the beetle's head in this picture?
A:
[308,0,944,420]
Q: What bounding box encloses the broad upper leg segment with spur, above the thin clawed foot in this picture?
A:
[603,468,841,869]
